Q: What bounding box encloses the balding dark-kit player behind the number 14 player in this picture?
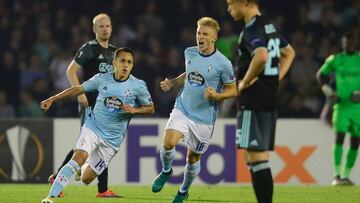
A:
[49,13,121,197]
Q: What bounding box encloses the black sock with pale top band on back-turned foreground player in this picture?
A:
[249,161,274,203]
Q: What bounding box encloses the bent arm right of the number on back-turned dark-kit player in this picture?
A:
[279,44,295,80]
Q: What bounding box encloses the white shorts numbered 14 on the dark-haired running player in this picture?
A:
[75,126,117,175]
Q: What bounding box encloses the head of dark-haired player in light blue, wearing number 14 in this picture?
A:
[113,52,134,80]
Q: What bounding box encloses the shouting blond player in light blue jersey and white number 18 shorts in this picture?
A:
[152,17,236,203]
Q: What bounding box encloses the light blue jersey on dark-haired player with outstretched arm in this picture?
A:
[82,73,152,149]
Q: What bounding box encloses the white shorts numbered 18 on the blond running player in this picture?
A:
[165,108,214,154]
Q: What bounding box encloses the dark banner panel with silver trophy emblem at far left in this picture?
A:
[0,119,53,183]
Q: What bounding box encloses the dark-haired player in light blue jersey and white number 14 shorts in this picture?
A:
[41,48,154,203]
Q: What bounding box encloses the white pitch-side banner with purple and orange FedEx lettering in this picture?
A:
[54,119,360,185]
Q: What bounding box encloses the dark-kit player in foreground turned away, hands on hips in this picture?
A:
[227,0,295,203]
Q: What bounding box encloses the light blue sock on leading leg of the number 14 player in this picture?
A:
[48,160,80,197]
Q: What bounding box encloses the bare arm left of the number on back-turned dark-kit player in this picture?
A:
[238,47,268,95]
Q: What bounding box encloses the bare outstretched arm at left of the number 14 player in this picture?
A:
[40,85,84,111]
